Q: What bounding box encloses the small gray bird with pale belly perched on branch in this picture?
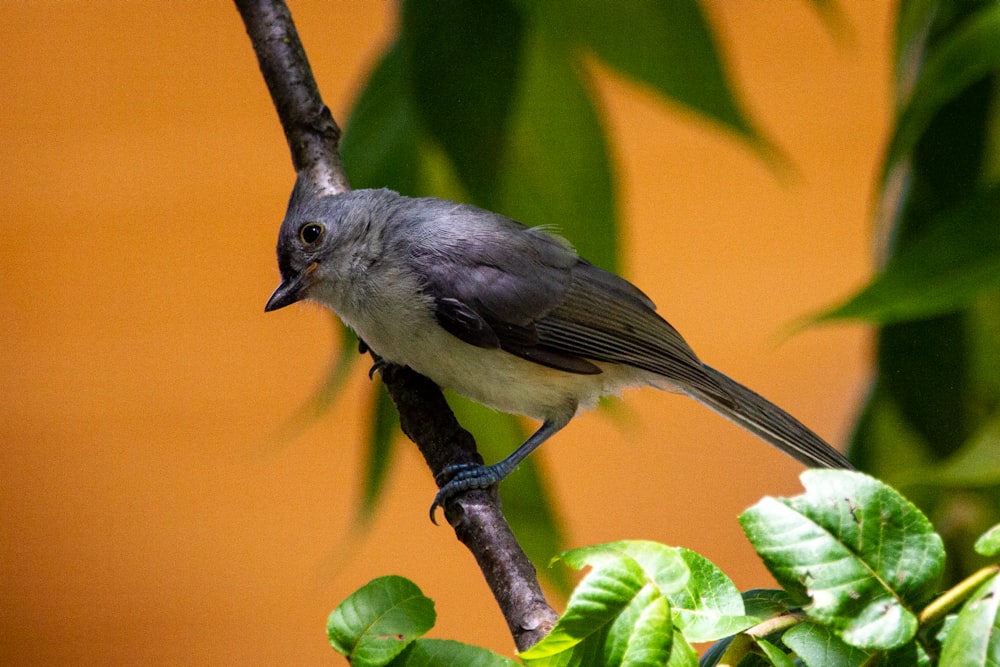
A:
[264,177,853,520]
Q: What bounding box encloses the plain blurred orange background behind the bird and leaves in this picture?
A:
[0,0,891,664]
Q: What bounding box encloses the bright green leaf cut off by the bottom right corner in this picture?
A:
[941,576,1000,667]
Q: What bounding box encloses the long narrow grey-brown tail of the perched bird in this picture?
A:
[688,366,854,470]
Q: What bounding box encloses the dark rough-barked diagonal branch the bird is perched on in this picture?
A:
[235,0,557,651]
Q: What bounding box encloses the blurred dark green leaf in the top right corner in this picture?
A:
[883,3,1000,183]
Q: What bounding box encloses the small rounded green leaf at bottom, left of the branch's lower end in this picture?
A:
[326,575,436,667]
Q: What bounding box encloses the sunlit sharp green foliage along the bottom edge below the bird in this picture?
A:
[329,470,1000,667]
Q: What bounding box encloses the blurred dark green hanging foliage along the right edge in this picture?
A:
[821,0,1000,581]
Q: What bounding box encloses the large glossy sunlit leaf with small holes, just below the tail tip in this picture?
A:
[740,470,944,649]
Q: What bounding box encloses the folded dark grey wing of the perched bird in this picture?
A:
[414,205,725,394]
